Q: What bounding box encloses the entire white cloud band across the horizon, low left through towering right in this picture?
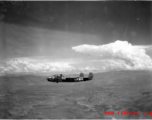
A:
[0,40,152,75]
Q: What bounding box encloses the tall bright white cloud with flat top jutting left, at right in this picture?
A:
[72,40,152,70]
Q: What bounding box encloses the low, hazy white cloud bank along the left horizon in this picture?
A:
[0,57,101,75]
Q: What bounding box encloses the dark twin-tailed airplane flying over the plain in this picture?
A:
[47,72,93,83]
